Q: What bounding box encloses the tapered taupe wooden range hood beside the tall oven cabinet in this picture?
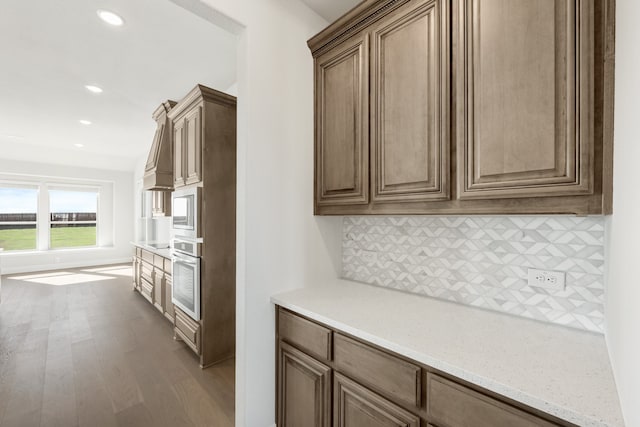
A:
[143,100,176,191]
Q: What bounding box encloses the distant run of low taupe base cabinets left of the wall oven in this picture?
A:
[133,246,174,323]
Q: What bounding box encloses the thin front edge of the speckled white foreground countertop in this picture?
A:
[271,292,619,427]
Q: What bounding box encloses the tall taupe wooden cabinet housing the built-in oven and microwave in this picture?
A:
[169,85,236,367]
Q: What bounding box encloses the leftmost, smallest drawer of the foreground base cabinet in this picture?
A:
[278,309,332,360]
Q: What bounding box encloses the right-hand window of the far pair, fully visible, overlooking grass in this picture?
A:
[49,190,98,249]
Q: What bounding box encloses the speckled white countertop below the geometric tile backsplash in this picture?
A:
[271,279,624,427]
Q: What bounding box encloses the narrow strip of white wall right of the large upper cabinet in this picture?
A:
[605,0,640,426]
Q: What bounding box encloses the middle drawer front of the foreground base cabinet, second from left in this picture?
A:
[333,334,421,407]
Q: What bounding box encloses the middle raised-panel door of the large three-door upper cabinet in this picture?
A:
[371,0,450,203]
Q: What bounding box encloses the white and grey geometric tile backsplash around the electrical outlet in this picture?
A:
[342,216,604,333]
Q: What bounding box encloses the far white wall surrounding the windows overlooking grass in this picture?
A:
[0,159,133,274]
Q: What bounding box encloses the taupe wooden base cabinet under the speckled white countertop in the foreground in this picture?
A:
[276,307,572,427]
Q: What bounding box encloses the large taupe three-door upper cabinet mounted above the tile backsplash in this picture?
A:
[308,0,613,215]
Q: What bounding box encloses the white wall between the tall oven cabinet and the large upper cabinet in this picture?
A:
[169,0,341,427]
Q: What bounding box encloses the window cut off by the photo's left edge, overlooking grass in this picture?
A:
[0,186,38,251]
